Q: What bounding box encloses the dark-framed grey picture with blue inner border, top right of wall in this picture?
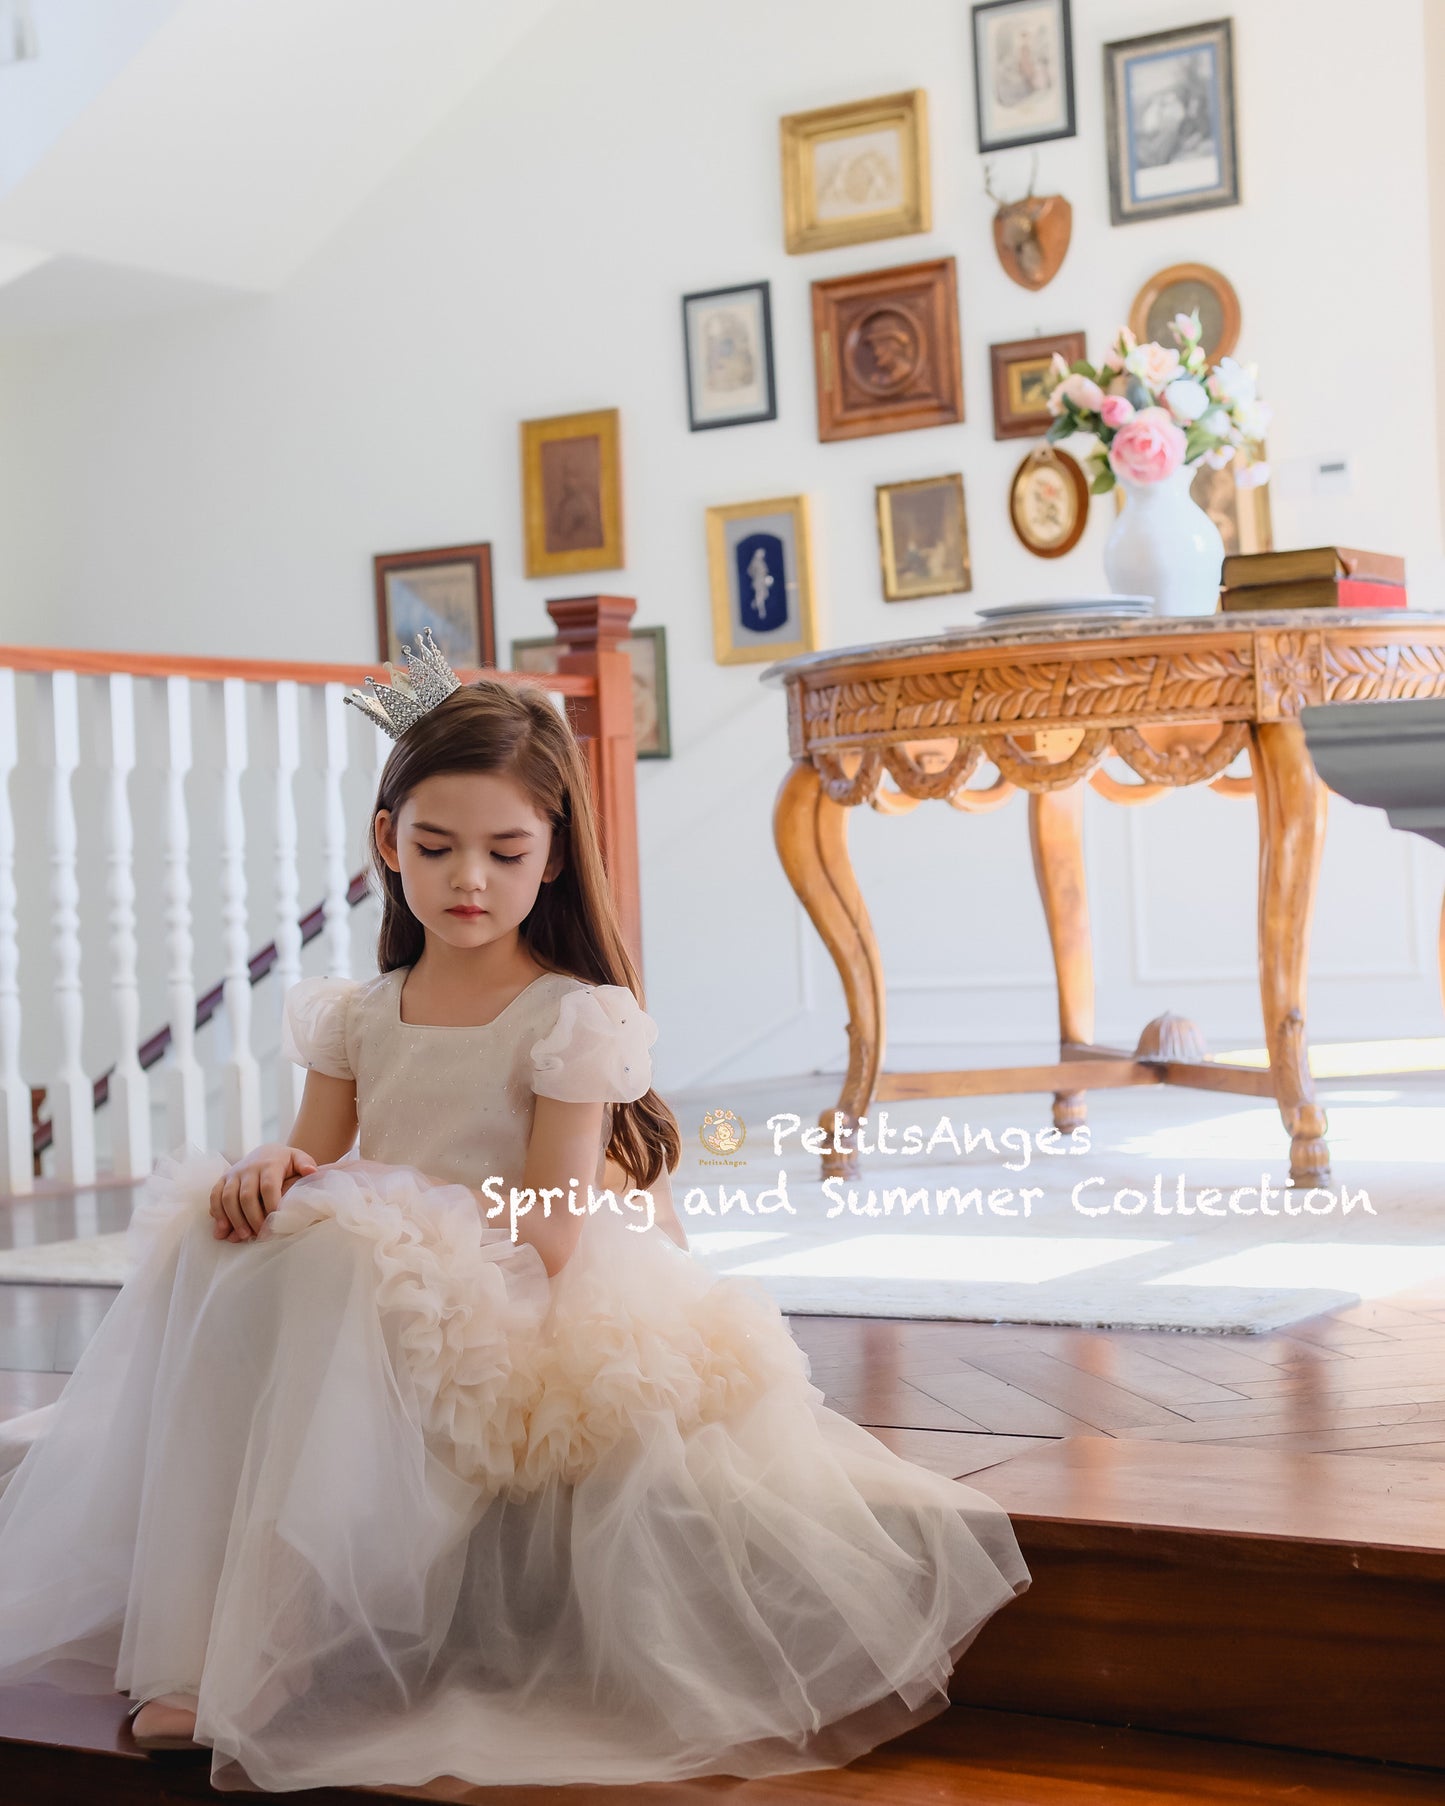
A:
[1104,18,1239,226]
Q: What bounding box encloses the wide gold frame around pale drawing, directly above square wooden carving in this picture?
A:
[778,88,932,253]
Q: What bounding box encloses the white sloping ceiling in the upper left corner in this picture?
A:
[0,0,555,330]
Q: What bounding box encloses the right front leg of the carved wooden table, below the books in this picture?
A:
[1250,721,1329,1185]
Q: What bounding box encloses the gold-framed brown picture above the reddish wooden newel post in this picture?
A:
[522,408,623,576]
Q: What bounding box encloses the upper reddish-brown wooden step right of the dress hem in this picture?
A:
[952,1436,1445,1769]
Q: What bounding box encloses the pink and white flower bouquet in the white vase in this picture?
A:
[1048,312,1270,495]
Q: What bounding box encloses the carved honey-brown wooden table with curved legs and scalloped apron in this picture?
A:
[762,609,1445,1185]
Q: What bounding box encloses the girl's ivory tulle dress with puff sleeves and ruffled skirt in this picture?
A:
[0,970,1030,1790]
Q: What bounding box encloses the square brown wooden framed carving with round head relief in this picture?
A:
[813,256,963,441]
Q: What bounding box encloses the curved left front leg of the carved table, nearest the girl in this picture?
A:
[773,759,883,1178]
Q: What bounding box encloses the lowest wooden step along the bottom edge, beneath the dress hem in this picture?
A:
[0,1685,1441,1806]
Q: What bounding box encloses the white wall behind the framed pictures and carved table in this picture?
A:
[0,0,1445,1084]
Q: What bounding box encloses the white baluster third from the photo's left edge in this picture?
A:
[103,672,150,1179]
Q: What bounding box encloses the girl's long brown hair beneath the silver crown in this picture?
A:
[367,677,683,1187]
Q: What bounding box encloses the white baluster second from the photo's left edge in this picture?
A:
[42,672,96,1185]
